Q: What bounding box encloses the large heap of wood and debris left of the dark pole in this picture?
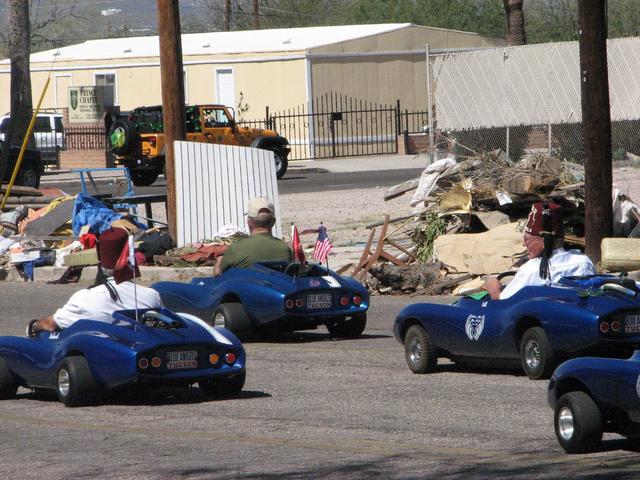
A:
[362,150,604,294]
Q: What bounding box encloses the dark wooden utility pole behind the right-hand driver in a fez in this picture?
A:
[578,0,613,263]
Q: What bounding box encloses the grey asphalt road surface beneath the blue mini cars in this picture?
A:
[0,282,640,479]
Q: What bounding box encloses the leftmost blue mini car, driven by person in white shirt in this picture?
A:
[0,309,245,407]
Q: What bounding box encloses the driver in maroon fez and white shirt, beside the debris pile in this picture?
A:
[485,202,596,300]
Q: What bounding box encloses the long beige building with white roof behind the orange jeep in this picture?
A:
[0,24,504,119]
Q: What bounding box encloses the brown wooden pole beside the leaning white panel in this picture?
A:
[157,0,187,240]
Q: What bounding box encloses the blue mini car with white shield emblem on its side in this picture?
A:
[393,276,640,379]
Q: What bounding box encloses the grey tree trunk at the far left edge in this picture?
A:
[0,0,33,180]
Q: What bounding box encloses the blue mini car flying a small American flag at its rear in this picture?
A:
[151,262,369,340]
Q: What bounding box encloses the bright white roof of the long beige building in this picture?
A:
[18,23,416,63]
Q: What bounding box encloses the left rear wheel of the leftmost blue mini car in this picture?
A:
[56,356,98,407]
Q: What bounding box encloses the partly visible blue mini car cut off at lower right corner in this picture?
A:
[548,350,640,453]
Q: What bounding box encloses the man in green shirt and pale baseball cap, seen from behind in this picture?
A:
[213,197,293,276]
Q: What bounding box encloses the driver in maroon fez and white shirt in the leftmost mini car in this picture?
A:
[27,228,163,336]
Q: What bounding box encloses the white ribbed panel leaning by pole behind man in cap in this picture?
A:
[175,142,282,247]
